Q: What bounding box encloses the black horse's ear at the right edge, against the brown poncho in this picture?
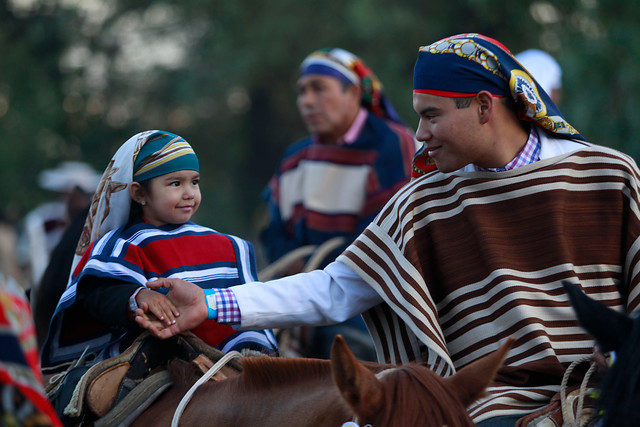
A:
[562,280,633,353]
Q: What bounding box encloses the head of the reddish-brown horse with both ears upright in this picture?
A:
[331,335,513,427]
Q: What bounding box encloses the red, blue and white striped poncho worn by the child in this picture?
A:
[42,222,277,371]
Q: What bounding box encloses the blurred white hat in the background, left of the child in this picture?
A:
[38,162,101,193]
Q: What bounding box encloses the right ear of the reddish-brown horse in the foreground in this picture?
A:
[443,337,515,407]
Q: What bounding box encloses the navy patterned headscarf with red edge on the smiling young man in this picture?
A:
[413,33,584,177]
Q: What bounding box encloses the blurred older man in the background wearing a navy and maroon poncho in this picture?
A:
[261,48,422,359]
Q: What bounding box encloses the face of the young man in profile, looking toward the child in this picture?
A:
[413,93,491,172]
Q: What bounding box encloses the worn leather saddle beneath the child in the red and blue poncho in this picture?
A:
[64,331,242,426]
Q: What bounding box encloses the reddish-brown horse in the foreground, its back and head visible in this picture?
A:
[133,336,513,427]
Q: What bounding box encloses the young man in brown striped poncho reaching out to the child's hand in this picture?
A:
[137,34,640,426]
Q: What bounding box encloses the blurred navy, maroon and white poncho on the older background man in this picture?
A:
[261,114,416,262]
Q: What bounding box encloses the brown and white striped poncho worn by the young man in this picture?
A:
[338,145,640,422]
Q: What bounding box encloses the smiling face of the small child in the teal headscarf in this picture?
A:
[142,170,202,227]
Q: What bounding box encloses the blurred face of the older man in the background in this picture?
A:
[296,74,360,142]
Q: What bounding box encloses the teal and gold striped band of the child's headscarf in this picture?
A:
[133,131,200,182]
